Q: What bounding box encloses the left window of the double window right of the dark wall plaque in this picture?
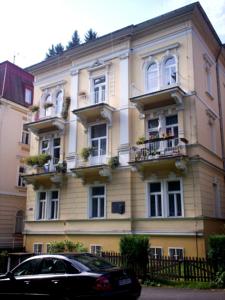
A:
[149,182,162,217]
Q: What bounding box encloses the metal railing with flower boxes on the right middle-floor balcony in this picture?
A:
[130,136,188,162]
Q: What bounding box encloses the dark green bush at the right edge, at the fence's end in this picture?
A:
[208,235,225,271]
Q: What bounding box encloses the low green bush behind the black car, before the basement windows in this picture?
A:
[49,240,87,253]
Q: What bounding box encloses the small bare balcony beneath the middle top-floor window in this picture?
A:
[73,102,115,129]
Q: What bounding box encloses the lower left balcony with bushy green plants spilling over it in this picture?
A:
[22,159,67,189]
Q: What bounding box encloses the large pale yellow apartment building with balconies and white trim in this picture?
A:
[25,3,225,256]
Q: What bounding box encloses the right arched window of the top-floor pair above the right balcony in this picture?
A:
[163,56,177,86]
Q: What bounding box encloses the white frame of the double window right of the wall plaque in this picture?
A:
[146,177,184,219]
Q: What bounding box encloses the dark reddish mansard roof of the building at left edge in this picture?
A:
[0,61,34,106]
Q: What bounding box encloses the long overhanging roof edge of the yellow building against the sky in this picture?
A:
[25,2,222,73]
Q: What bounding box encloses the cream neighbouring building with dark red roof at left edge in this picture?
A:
[0,61,33,251]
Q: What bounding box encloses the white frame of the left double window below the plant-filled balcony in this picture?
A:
[36,189,60,221]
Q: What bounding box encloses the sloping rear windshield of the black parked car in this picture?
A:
[66,254,116,272]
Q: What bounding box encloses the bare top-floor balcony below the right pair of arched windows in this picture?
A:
[130,86,185,113]
